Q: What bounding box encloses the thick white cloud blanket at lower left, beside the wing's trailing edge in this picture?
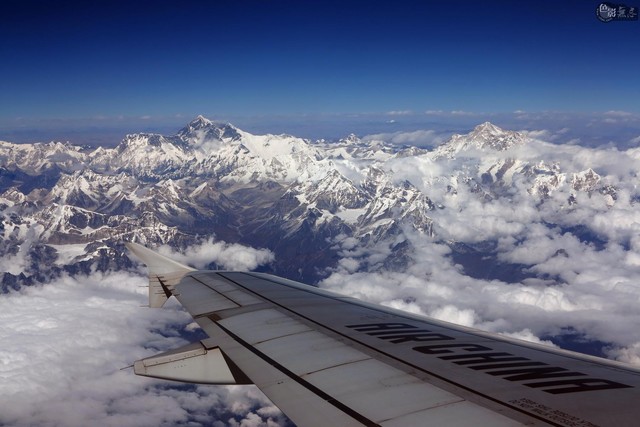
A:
[0,272,286,427]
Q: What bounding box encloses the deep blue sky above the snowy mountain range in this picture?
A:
[0,0,640,142]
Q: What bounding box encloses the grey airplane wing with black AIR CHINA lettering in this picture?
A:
[127,243,640,427]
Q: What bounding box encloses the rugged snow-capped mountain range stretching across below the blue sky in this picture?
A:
[0,116,636,287]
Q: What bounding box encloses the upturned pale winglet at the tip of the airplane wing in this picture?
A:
[125,242,195,308]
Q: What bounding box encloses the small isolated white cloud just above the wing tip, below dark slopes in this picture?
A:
[158,238,275,271]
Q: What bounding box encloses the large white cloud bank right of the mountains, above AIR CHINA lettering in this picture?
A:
[320,135,640,364]
